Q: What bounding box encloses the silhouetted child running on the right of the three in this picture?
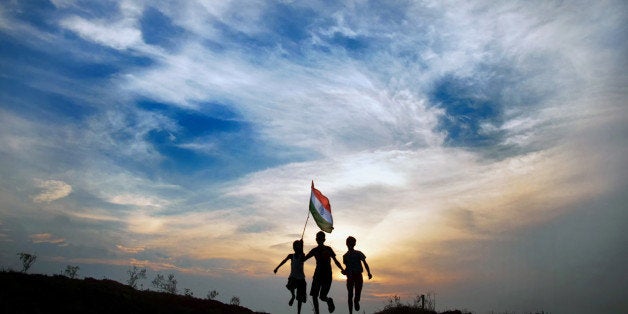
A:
[342,236,373,314]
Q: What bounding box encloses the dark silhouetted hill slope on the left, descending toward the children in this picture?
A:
[0,271,268,314]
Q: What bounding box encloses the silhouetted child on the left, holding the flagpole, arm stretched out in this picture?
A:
[273,240,307,314]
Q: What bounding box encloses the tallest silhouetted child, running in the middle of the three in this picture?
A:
[305,231,344,314]
